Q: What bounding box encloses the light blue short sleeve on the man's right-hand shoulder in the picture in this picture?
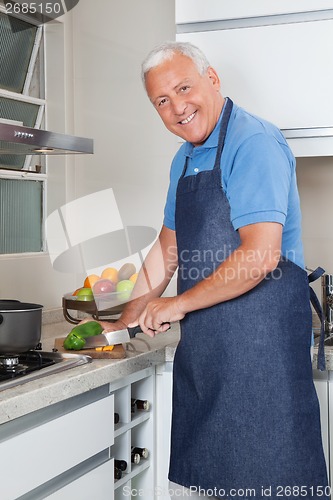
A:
[225,133,292,230]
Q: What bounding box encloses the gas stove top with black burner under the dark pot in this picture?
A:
[0,346,92,391]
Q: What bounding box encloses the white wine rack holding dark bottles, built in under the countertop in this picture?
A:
[110,368,155,500]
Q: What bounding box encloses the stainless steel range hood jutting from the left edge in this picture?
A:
[0,122,94,155]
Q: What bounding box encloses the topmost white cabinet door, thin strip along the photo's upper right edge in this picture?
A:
[176,0,333,23]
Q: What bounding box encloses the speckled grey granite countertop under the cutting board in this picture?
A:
[0,314,333,424]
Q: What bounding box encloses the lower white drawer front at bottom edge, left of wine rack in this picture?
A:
[46,460,114,500]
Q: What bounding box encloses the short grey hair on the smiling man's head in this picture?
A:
[141,42,210,86]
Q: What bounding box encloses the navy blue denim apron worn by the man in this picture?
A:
[169,99,329,500]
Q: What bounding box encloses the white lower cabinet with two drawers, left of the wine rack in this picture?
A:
[0,386,114,500]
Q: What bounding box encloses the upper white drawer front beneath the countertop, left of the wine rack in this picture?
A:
[0,395,114,500]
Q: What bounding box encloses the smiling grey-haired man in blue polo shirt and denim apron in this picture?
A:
[108,42,329,500]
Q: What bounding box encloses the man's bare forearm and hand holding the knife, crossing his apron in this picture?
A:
[131,222,282,336]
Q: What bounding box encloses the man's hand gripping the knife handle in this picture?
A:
[128,297,185,337]
